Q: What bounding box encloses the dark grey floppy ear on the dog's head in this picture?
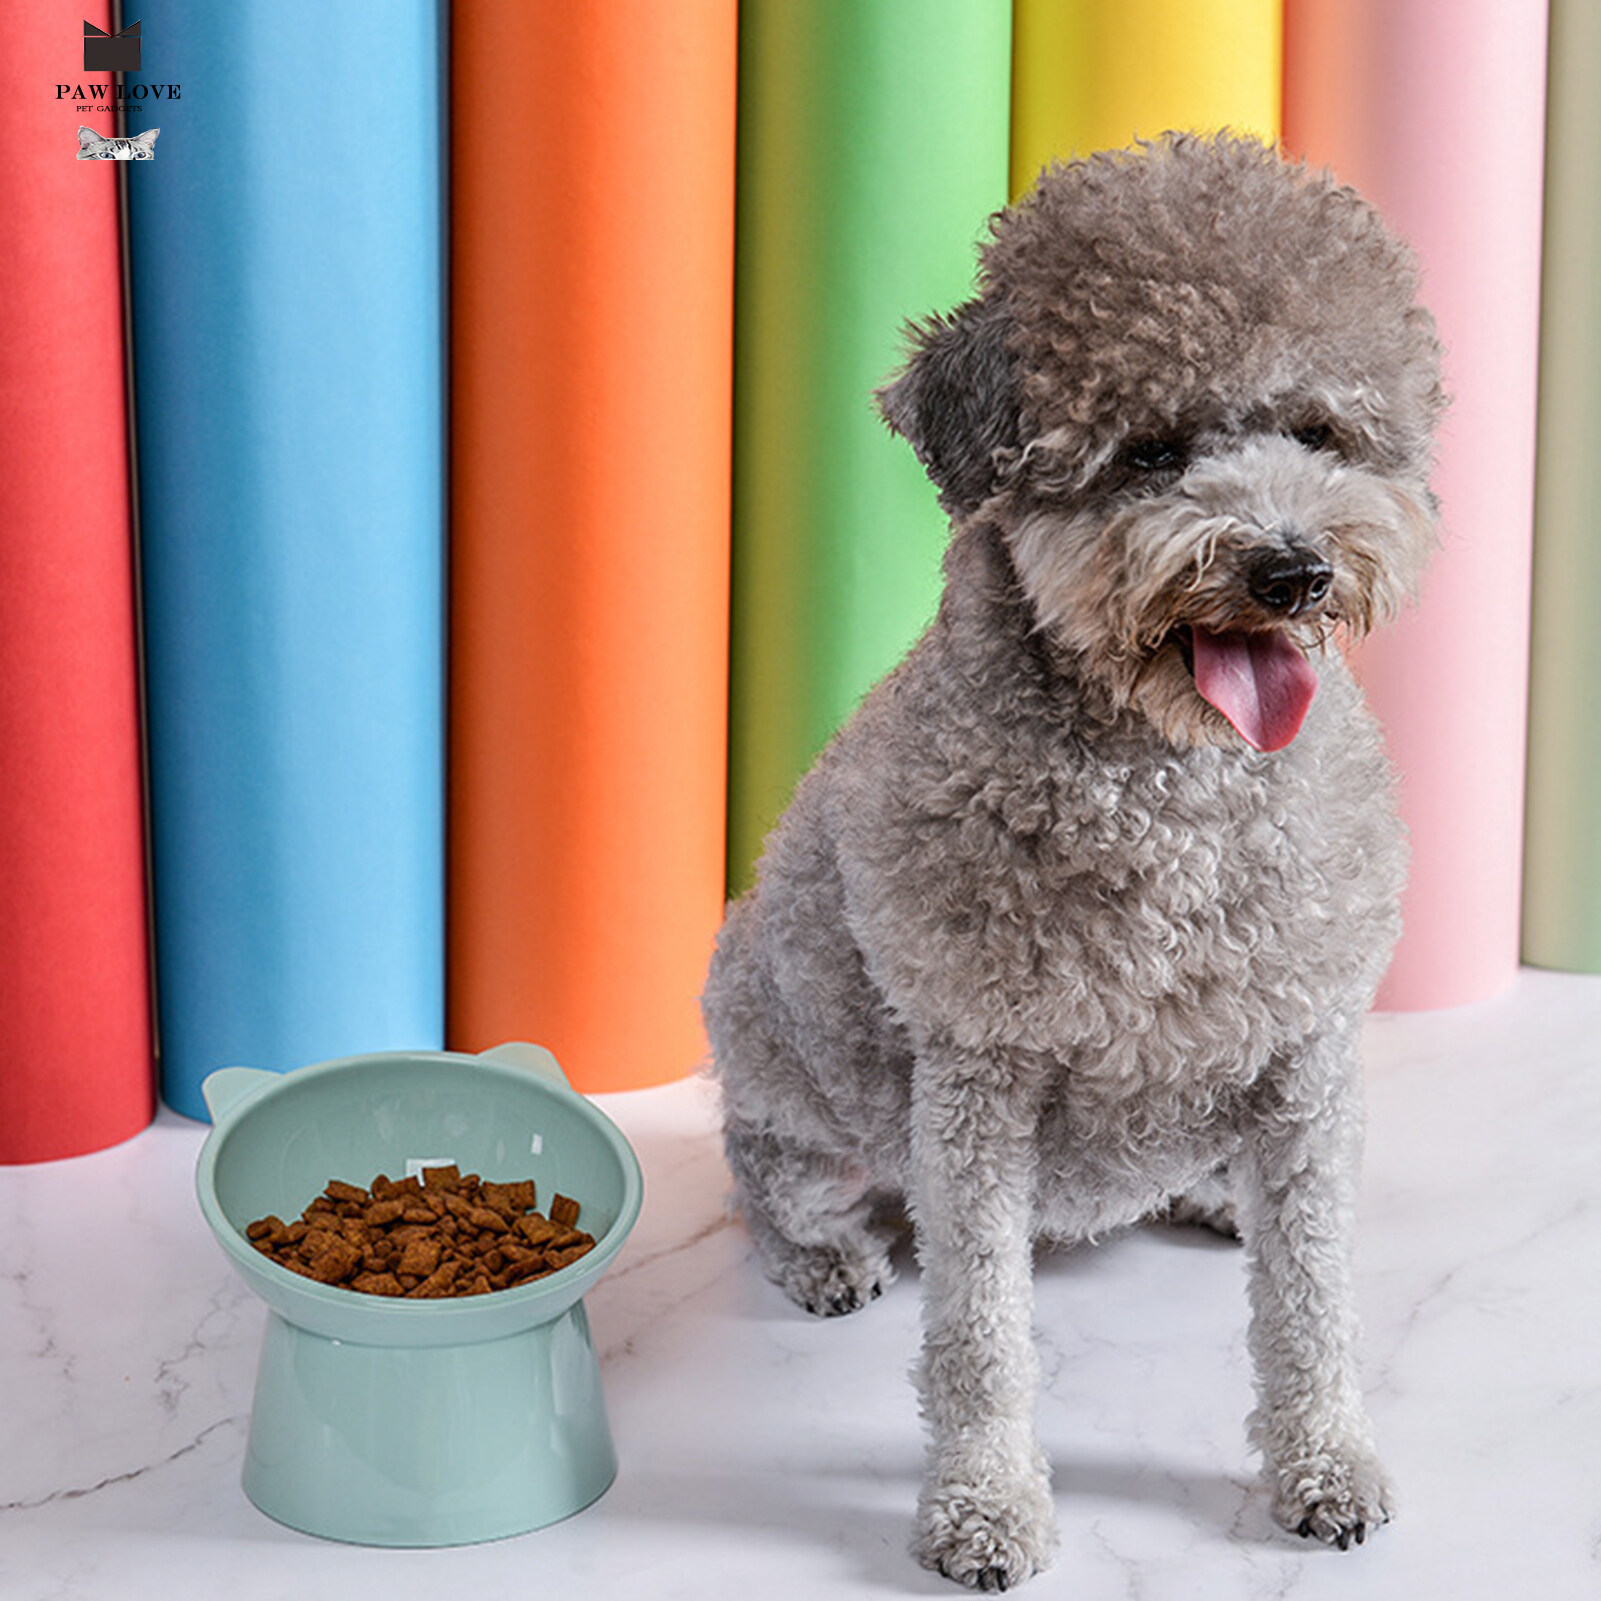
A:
[877,299,1018,516]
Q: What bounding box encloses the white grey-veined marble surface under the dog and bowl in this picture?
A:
[0,972,1601,1601]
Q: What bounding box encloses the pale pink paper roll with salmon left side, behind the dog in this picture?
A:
[1286,0,1547,1009]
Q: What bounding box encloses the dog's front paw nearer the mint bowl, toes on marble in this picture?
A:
[913,1478,1057,1590]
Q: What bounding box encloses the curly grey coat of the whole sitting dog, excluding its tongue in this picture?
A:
[703,136,1441,1590]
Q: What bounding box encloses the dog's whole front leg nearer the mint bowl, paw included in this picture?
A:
[909,1047,1057,1590]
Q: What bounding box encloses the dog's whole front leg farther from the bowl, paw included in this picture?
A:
[1239,1023,1391,1550]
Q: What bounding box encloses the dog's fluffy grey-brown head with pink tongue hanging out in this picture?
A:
[879,134,1443,749]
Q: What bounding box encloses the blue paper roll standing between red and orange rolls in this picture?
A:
[128,0,443,1117]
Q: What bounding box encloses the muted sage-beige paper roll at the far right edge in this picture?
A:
[1523,0,1601,973]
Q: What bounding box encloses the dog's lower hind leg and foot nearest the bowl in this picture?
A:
[724,1122,895,1318]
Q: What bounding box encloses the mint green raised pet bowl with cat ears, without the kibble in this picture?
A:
[195,1044,640,1547]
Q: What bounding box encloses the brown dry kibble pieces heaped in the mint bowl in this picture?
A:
[245,1167,594,1300]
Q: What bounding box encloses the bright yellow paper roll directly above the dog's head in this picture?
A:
[1012,0,1282,194]
